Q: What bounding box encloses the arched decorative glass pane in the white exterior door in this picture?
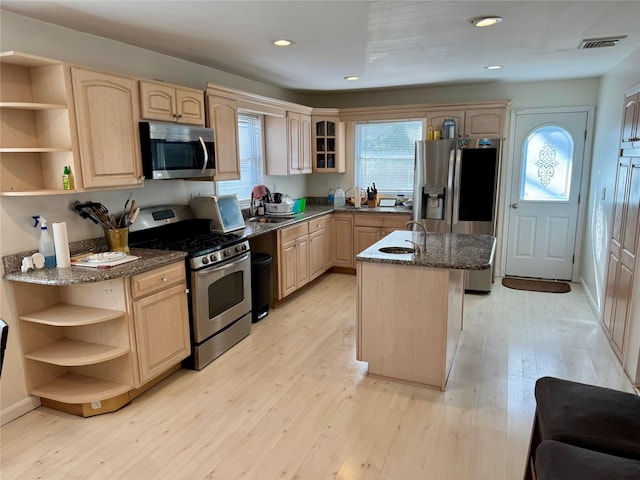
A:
[520,126,573,202]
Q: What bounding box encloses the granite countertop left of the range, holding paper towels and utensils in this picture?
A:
[2,248,187,286]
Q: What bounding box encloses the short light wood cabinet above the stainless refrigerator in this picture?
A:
[426,108,505,138]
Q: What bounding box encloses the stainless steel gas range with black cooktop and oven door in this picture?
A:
[129,205,251,370]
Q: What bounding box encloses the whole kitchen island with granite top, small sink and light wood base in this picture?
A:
[355,230,495,390]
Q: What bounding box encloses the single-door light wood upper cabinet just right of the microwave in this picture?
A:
[207,95,240,181]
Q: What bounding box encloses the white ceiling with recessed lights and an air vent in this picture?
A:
[0,0,640,91]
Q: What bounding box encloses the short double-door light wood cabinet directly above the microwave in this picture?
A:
[140,80,204,126]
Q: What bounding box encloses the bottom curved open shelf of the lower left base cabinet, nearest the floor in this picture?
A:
[30,372,131,403]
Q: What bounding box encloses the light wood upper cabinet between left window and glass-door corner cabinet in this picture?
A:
[264,112,311,175]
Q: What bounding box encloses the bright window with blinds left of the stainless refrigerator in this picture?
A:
[356,120,422,192]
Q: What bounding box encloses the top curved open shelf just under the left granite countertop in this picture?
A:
[20,303,125,327]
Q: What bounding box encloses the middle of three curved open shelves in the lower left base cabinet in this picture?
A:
[25,338,129,367]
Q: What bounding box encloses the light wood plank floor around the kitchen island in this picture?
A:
[0,274,632,480]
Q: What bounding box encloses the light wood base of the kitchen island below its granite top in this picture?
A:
[356,262,464,390]
